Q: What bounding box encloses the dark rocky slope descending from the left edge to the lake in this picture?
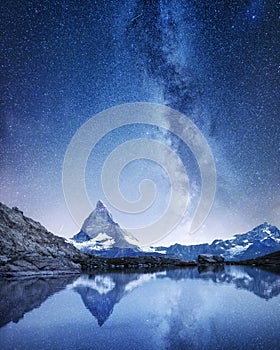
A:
[0,203,85,276]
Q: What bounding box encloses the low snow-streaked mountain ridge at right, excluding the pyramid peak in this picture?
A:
[154,222,280,260]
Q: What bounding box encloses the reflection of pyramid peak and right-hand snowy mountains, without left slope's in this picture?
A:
[73,266,280,326]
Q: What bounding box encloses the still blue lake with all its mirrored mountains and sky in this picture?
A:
[0,266,280,350]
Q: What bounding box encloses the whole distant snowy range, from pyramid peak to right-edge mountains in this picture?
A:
[68,201,280,261]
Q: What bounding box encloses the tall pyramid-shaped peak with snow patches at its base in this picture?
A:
[68,201,140,257]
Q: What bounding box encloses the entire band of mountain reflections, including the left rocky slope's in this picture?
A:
[0,266,280,327]
